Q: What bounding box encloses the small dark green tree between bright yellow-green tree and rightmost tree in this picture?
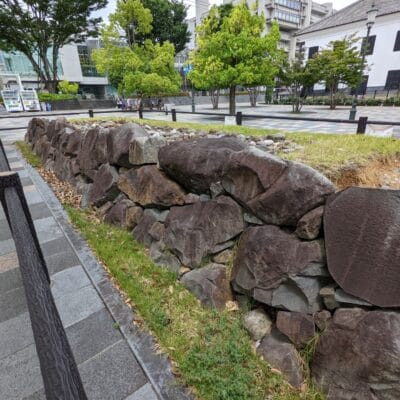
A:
[279,50,318,113]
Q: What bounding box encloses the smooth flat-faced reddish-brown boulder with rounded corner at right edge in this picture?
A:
[324,188,400,307]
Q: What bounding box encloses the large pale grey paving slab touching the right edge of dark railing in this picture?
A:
[55,286,104,327]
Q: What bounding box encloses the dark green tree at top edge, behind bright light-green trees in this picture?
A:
[136,0,190,53]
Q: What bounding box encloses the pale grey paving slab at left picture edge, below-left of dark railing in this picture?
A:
[0,312,33,360]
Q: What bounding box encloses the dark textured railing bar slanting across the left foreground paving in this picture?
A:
[0,172,87,400]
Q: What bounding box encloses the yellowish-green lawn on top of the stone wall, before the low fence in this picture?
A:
[71,117,400,179]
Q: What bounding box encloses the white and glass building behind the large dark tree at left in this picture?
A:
[0,39,111,98]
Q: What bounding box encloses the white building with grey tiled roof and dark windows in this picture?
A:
[296,0,400,91]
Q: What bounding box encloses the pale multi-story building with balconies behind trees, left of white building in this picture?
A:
[224,0,334,55]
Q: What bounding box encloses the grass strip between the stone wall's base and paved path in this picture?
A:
[17,142,323,400]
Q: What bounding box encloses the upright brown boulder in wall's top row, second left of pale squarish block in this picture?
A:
[78,127,109,176]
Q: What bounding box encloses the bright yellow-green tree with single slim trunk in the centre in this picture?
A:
[189,1,281,115]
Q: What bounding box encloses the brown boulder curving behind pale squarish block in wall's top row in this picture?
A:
[107,123,148,168]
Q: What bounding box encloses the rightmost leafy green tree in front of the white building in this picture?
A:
[309,36,365,110]
